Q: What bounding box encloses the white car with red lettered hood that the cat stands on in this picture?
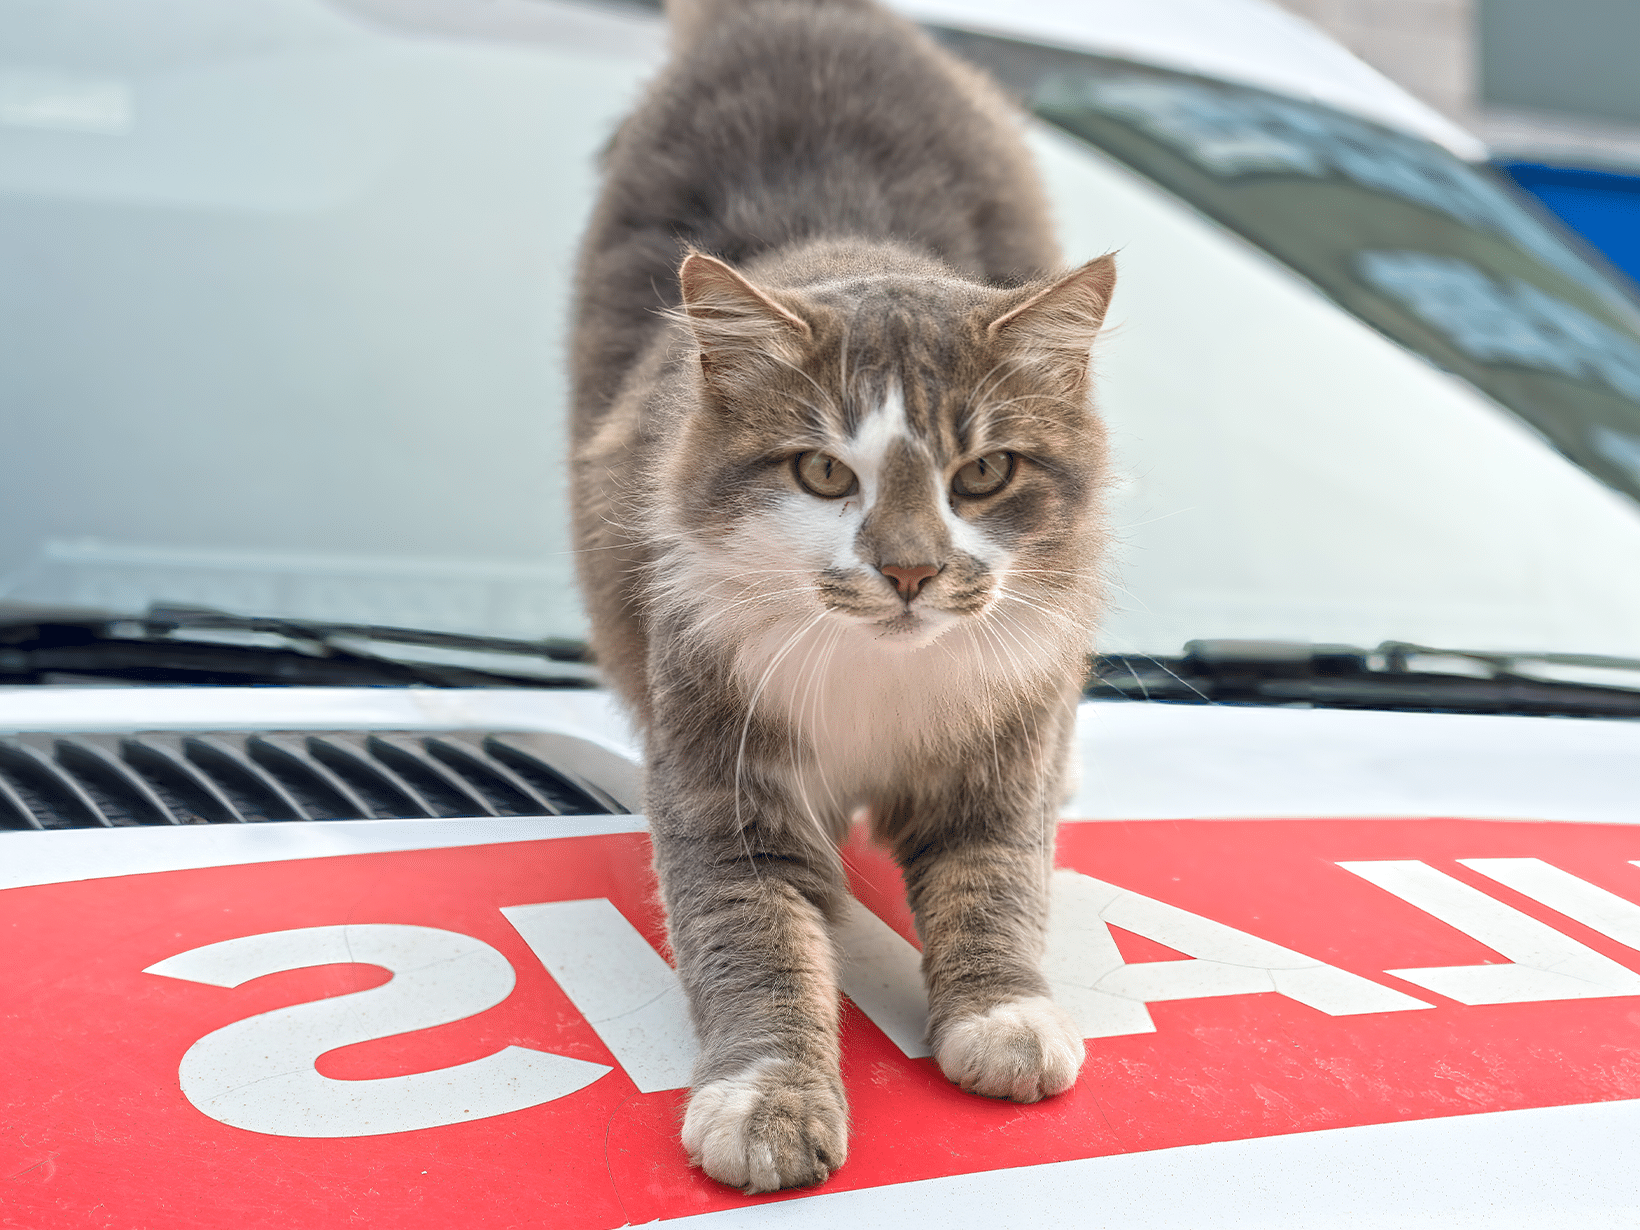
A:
[0,0,1640,1230]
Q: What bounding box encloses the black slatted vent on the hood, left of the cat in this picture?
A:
[0,730,638,828]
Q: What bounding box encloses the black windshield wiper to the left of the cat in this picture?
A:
[0,604,597,687]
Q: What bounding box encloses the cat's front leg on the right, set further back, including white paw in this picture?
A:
[895,790,1086,1102]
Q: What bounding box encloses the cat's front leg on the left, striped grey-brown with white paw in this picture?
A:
[649,757,848,1192]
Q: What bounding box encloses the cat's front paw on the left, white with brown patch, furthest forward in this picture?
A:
[684,1059,848,1196]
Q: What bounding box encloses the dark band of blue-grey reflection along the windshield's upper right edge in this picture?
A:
[941,31,1640,502]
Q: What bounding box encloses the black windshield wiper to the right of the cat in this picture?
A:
[1086,640,1640,717]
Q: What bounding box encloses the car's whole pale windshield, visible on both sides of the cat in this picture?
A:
[0,0,1640,675]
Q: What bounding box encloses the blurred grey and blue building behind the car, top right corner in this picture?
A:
[1276,0,1640,288]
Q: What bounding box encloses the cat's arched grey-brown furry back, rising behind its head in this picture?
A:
[574,0,1058,440]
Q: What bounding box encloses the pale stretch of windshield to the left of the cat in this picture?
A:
[0,0,663,649]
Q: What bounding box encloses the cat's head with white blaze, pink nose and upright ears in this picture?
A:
[661,249,1115,665]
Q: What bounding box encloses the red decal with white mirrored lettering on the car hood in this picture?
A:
[9,820,1640,1230]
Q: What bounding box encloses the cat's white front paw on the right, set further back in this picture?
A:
[935,995,1087,1102]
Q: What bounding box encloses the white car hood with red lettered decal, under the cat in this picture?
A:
[9,689,1640,1227]
